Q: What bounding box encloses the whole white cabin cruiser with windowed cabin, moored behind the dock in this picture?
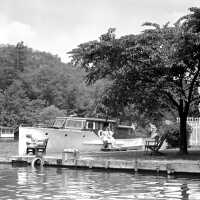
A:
[19,117,144,155]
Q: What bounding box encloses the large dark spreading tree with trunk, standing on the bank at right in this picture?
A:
[70,8,200,154]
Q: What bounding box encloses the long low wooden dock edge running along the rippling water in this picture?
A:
[5,153,200,174]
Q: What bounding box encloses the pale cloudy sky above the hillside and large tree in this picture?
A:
[0,0,200,62]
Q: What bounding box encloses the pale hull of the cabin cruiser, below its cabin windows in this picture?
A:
[18,127,145,155]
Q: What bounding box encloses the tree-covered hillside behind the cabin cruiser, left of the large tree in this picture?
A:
[0,42,109,126]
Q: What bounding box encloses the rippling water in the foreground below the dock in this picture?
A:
[0,165,200,200]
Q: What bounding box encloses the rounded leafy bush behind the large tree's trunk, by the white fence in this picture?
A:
[163,123,192,147]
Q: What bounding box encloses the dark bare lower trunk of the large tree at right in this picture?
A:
[179,115,188,154]
